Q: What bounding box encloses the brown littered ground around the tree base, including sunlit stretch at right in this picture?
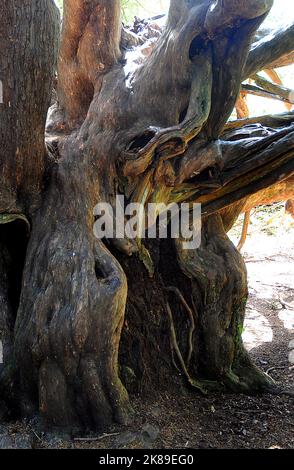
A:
[0,204,294,449]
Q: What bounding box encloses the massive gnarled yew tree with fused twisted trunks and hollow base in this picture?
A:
[0,0,294,429]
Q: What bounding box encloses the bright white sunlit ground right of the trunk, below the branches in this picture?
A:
[230,203,294,370]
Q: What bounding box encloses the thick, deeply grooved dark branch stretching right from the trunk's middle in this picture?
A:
[169,117,294,215]
